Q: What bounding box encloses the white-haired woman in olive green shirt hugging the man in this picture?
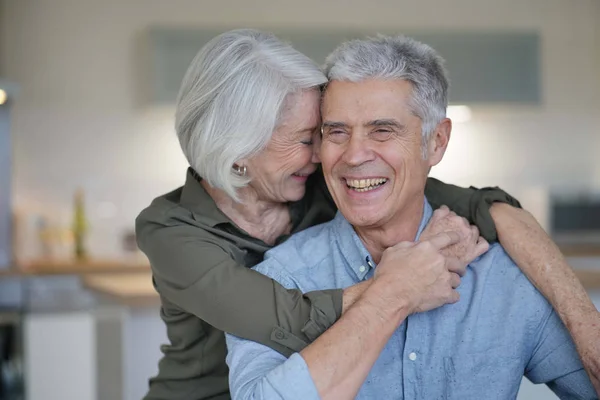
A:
[136,30,600,400]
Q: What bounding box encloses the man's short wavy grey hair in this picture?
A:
[325,35,448,156]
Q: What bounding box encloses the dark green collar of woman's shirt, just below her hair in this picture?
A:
[181,168,232,227]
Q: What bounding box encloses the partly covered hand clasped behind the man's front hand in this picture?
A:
[420,206,489,276]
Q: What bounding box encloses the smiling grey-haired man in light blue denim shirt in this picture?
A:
[227,37,596,399]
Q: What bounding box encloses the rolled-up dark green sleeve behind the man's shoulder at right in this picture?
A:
[425,178,521,242]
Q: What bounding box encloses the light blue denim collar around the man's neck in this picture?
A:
[333,197,433,281]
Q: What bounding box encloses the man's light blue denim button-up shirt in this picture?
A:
[227,200,597,400]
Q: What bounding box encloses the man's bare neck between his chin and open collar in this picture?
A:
[354,196,424,263]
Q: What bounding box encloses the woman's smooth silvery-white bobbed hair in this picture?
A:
[175,29,327,201]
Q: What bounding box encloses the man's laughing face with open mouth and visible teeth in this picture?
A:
[319,80,450,228]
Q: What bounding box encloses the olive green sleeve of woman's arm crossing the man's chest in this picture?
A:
[136,212,343,356]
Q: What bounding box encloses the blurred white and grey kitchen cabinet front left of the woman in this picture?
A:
[24,305,167,400]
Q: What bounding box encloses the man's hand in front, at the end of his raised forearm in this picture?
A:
[373,231,463,313]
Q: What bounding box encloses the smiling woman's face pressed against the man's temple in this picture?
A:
[246,89,321,203]
